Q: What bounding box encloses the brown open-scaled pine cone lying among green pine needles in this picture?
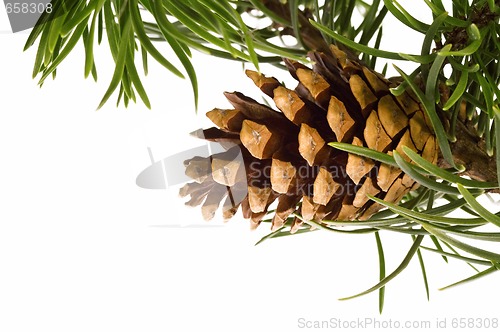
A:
[180,45,438,232]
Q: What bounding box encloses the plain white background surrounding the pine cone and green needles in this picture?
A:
[0,3,500,332]
